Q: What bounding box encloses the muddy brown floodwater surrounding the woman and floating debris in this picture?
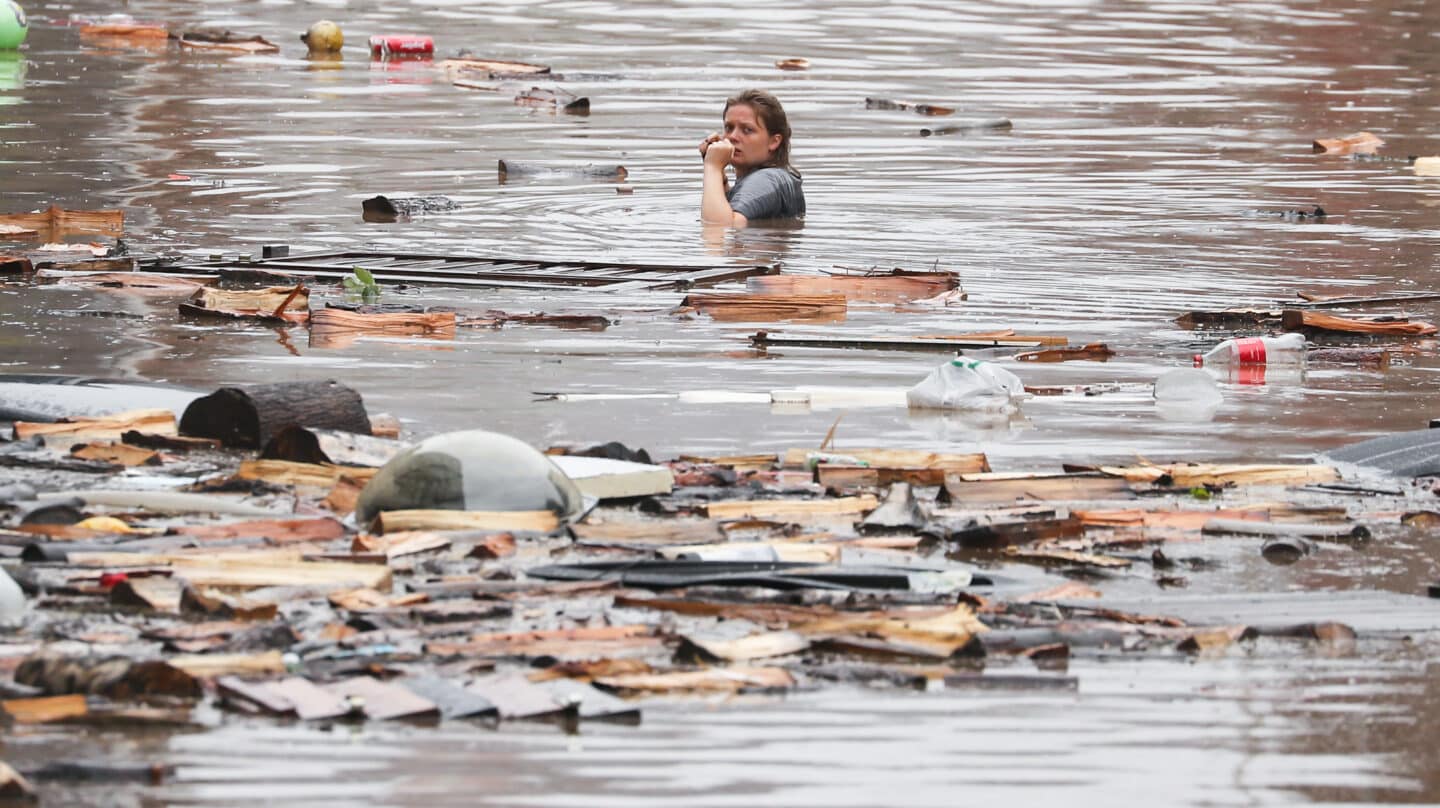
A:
[0,0,1440,807]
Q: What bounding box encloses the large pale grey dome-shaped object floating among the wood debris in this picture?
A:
[356,429,585,524]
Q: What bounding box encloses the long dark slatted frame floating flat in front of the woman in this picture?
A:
[168,251,775,291]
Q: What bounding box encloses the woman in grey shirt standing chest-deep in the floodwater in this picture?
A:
[700,89,805,228]
